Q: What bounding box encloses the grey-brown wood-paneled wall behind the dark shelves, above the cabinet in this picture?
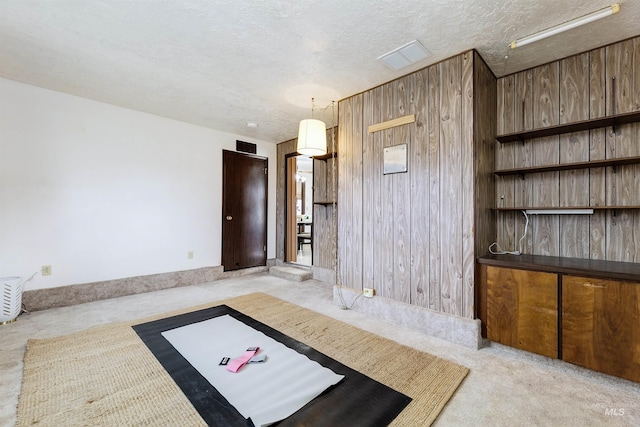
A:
[495,38,640,262]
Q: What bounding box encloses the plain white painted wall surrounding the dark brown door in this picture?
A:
[0,79,276,289]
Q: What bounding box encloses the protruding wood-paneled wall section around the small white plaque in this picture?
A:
[338,51,496,318]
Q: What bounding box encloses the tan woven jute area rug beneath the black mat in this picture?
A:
[17,293,468,426]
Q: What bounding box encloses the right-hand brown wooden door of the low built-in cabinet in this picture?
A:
[562,276,640,381]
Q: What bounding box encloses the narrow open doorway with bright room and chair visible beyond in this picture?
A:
[285,153,313,266]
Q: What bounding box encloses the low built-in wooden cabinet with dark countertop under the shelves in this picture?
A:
[476,255,640,382]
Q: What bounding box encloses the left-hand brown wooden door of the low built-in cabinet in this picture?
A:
[487,266,558,358]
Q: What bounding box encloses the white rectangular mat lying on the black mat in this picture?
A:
[162,315,344,426]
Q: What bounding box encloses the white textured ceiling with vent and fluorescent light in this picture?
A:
[0,0,640,142]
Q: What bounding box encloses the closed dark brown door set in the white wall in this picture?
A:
[222,150,268,271]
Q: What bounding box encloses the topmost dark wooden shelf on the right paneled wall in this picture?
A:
[496,111,640,143]
